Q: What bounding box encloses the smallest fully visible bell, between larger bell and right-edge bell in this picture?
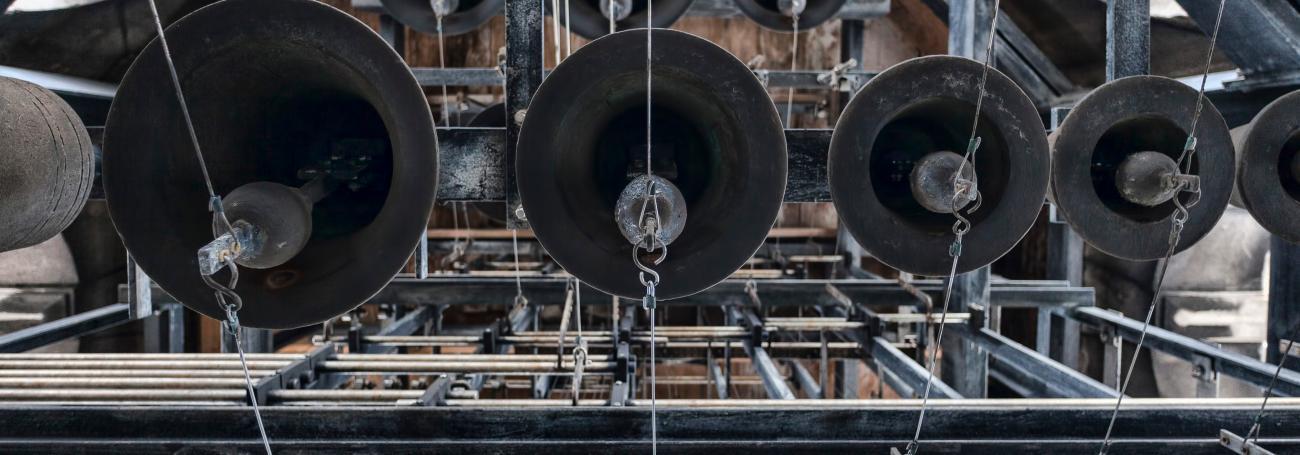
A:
[1052,75,1235,260]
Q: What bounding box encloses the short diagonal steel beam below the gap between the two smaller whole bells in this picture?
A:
[948,324,1119,398]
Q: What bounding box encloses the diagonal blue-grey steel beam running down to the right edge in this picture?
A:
[1070,307,1300,397]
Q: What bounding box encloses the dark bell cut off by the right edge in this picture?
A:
[1232,91,1300,243]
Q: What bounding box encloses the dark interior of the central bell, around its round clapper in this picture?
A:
[555,72,743,257]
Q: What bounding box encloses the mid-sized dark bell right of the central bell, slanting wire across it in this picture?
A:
[827,56,1049,276]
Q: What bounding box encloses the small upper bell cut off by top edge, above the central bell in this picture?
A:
[542,0,694,39]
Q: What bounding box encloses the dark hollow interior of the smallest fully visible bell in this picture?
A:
[1080,116,1197,222]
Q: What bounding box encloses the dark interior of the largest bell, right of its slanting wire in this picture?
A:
[183,42,393,247]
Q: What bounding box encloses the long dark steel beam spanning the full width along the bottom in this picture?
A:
[0,399,1300,455]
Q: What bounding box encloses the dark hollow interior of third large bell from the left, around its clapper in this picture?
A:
[868,98,1010,235]
